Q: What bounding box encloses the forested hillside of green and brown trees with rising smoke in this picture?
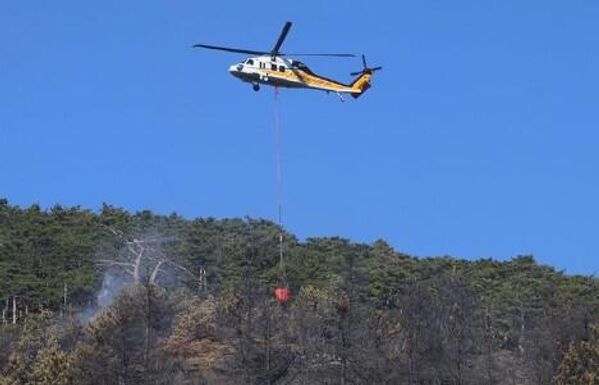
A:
[0,200,599,385]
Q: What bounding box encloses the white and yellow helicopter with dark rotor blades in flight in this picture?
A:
[193,21,382,101]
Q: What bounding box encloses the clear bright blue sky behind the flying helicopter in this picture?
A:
[0,0,599,273]
